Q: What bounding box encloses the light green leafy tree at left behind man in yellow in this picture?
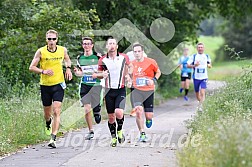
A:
[0,0,99,96]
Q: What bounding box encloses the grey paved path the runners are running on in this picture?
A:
[0,82,223,167]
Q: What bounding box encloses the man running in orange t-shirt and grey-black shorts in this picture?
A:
[129,44,161,142]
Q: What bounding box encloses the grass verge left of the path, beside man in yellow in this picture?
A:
[0,85,85,156]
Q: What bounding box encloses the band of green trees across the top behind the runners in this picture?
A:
[0,0,252,96]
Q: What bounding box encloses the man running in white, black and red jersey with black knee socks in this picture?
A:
[98,37,130,147]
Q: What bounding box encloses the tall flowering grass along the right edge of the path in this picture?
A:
[178,63,252,167]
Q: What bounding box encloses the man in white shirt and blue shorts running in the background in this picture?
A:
[187,43,212,111]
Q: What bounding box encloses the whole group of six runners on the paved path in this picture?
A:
[29,30,211,148]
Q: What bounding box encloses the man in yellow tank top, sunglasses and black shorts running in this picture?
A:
[29,30,72,148]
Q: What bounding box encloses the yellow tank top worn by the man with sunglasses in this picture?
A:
[40,45,65,86]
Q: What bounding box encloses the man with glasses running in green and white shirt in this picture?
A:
[74,37,102,140]
